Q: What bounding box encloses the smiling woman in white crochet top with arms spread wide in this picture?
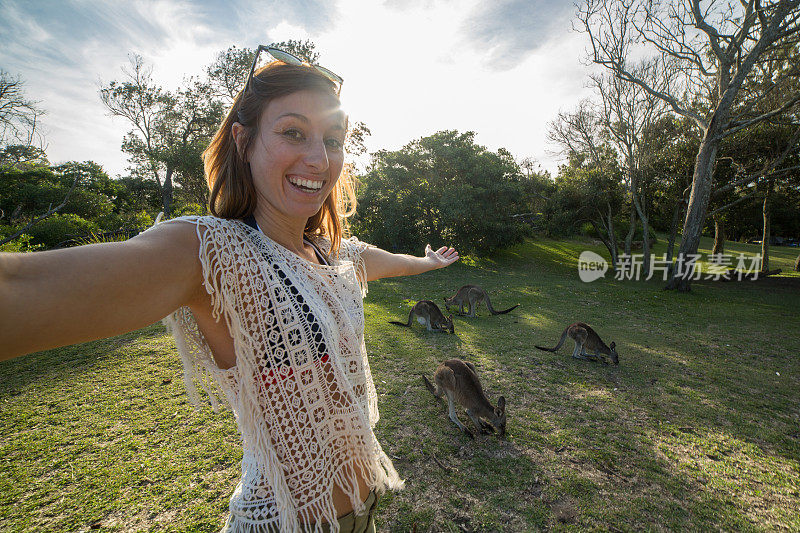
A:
[0,47,458,531]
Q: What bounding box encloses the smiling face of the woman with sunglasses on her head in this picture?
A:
[244,91,346,224]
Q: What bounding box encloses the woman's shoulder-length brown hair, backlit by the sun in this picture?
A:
[203,61,356,255]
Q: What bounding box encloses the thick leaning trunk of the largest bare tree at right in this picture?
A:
[665,131,719,292]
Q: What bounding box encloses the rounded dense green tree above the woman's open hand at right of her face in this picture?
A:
[353,131,528,254]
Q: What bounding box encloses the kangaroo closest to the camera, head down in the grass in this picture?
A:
[422,359,506,439]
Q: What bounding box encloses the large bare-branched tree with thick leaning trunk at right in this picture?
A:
[578,0,800,291]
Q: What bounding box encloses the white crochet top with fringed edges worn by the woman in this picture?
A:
[159,216,403,533]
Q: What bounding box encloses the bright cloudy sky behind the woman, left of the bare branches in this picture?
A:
[0,0,590,176]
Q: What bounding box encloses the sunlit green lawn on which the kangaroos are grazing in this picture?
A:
[0,235,800,532]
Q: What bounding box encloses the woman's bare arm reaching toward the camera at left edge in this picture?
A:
[0,218,205,360]
